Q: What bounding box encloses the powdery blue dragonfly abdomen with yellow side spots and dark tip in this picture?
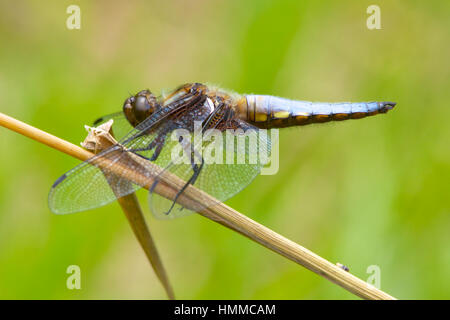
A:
[241,95,395,128]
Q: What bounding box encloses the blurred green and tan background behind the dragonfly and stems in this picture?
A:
[0,0,450,299]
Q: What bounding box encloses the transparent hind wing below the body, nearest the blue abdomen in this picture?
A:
[149,120,271,219]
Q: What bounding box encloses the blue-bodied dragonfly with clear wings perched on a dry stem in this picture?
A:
[49,83,396,219]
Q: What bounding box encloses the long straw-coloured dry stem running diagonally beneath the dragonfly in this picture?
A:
[0,113,395,299]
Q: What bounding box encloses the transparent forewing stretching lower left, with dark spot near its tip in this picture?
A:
[48,90,200,214]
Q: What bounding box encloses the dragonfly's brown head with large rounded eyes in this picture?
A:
[123,90,160,127]
